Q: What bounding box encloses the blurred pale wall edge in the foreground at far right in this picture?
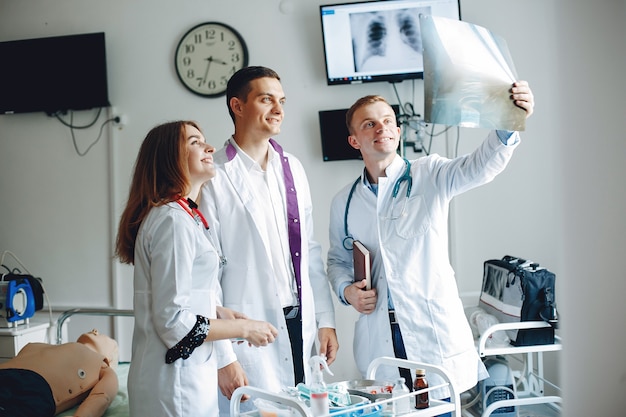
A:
[554,0,626,416]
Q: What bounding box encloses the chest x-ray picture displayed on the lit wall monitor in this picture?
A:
[350,7,431,72]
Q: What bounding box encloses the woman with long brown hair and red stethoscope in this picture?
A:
[116,121,278,417]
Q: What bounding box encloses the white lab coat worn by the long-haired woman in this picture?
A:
[128,202,219,417]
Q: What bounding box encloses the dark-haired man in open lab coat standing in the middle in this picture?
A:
[200,67,338,413]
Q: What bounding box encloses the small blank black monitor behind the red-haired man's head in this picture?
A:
[319,104,400,161]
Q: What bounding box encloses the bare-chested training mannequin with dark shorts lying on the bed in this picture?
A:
[0,329,118,417]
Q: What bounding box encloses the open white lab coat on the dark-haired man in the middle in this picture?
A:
[200,138,335,413]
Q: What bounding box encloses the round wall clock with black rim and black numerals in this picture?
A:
[175,22,248,97]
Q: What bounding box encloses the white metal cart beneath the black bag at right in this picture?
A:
[463,321,562,417]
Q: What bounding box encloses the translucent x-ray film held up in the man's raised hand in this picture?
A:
[420,15,526,131]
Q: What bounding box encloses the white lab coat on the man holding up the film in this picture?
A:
[328,132,517,398]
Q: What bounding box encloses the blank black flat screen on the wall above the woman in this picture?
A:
[0,32,110,114]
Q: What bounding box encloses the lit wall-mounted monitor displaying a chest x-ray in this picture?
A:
[320,0,461,85]
